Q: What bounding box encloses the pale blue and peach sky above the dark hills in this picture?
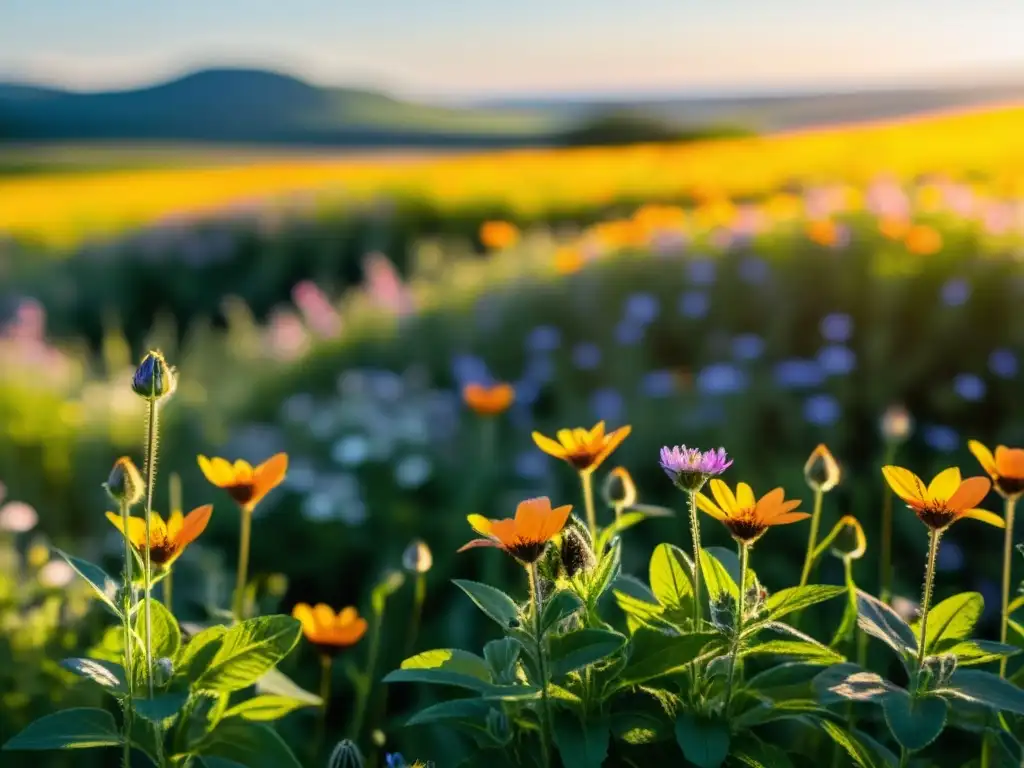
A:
[0,0,1024,96]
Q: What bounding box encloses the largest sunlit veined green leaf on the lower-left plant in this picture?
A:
[194,615,301,692]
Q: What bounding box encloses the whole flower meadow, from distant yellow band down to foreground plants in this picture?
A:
[0,108,1024,768]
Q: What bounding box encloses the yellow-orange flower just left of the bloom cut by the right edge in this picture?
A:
[882,465,1005,530]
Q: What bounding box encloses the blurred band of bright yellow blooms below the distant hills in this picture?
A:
[6,106,1024,248]
